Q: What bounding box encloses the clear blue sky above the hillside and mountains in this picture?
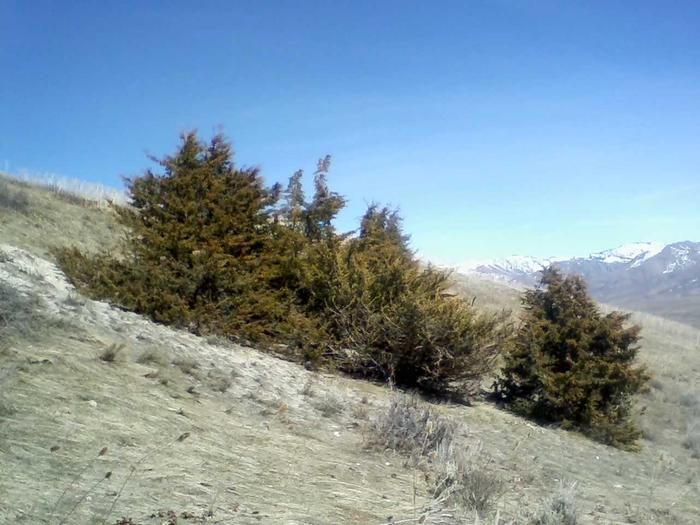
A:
[0,0,700,263]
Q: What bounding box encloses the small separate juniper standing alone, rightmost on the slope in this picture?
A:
[496,268,649,447]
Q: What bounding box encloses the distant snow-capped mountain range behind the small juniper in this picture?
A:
[460,241,700,327]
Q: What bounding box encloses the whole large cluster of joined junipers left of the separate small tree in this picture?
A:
[55,133,499,396]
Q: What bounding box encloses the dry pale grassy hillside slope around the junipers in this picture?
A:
[0,179,700,524]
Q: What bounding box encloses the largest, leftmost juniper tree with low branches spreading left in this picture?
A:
[58,133,304,338]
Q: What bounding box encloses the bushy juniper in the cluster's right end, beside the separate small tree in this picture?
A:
[302,206,504,392]
